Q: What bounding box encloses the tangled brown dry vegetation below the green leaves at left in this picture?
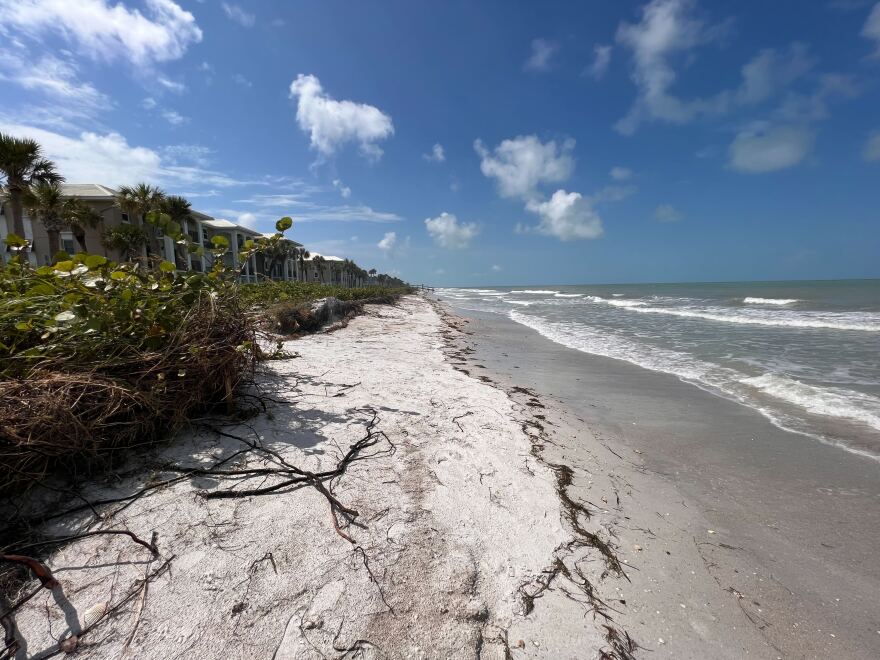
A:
[0,303,255,494]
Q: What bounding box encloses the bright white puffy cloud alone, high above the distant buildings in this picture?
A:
[290,74,394,160]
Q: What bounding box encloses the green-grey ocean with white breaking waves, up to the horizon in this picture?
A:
[437,280,880,461]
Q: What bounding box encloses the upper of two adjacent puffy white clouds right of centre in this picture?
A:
[474,135,574,199]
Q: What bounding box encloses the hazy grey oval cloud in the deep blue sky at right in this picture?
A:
[730,123,814,174]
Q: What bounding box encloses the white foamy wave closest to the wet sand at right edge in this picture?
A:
[740,373,880,430]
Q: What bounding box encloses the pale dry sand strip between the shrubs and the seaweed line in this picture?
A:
[14,296,633,658]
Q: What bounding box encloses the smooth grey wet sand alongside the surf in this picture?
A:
[456,310,880,658]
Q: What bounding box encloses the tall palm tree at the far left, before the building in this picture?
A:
[0,133,64,245]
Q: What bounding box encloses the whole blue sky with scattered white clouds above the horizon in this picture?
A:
[0,0,880,286]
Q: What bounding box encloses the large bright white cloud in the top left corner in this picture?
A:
[0,0,202,66]
